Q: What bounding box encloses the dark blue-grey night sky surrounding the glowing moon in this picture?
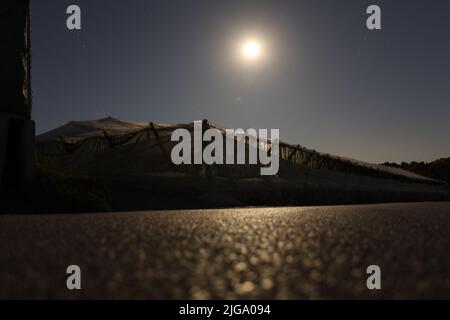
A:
[32,0,450,162]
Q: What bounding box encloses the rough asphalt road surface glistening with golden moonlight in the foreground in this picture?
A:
[0,203,450,299]
